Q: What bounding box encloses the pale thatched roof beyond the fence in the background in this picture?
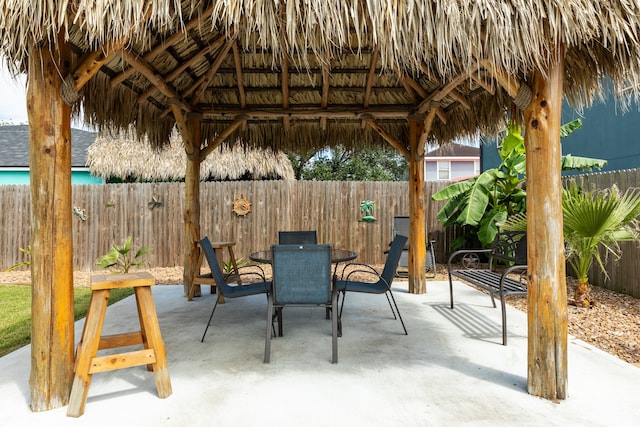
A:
[87,130,295,181]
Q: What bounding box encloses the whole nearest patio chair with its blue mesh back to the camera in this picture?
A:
[264,244,338,363]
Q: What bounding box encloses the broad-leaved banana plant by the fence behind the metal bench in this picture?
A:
[432,120,607,249]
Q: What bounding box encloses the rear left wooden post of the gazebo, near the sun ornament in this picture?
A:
[183,119,202,297]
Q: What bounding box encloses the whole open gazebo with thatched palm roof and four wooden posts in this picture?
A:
[0,0,640,411]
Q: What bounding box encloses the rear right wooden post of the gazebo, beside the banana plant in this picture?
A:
[408,120,427,294]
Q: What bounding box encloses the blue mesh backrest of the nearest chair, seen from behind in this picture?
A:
[271,245,331,305]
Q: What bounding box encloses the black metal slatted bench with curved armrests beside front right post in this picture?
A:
[447,231,527,345]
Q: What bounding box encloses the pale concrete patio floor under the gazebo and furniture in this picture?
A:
[0,281,640,426]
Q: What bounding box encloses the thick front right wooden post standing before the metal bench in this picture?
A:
[525,45,567,400]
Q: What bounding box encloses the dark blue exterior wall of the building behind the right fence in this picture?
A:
[480,101,640,174]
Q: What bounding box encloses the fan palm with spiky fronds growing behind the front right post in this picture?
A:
[502,180,640,307]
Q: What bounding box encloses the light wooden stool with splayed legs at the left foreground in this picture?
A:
[67,273,172,417]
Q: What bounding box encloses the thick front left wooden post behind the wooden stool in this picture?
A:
[27,37,74,411]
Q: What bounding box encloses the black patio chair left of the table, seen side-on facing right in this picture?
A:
[200,237,271,342]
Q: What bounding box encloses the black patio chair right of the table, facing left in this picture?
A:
[337,234,408,335]
